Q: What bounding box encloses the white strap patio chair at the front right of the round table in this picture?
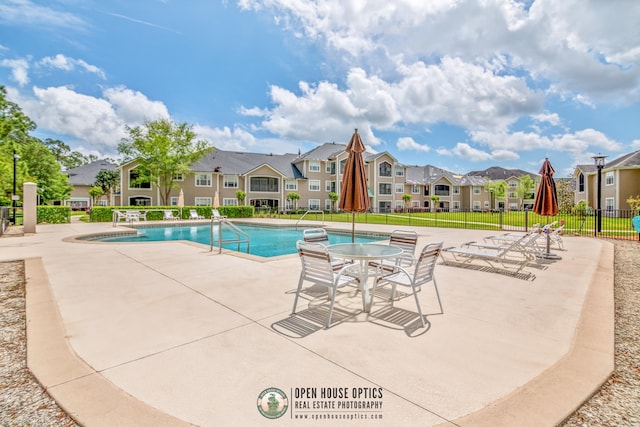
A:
[371,242,443,327]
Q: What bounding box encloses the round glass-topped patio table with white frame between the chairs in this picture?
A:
[327,243,402,313]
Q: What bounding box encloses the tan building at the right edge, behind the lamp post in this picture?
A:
[573,150,640,214]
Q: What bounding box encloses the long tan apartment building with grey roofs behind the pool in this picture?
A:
[120,142,535,212]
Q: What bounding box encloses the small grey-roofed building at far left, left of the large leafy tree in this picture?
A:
[64,160,120,209]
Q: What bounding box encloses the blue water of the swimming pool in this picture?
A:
[99,224,388,257]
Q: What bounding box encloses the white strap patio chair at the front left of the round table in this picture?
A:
[291,241,358,328]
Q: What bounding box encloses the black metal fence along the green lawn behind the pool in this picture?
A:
[276,209,640,241]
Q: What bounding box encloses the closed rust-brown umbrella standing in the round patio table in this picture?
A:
[338,129,371,242]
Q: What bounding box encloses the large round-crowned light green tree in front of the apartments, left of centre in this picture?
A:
[118,119,213,205]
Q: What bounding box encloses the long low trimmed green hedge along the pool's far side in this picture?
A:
[90,206,253,222]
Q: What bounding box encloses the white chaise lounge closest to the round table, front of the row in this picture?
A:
[442,233,540,272]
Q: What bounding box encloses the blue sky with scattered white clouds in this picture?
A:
[0,0,640,177]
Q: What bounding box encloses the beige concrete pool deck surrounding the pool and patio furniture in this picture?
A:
[0,220,614,426]
